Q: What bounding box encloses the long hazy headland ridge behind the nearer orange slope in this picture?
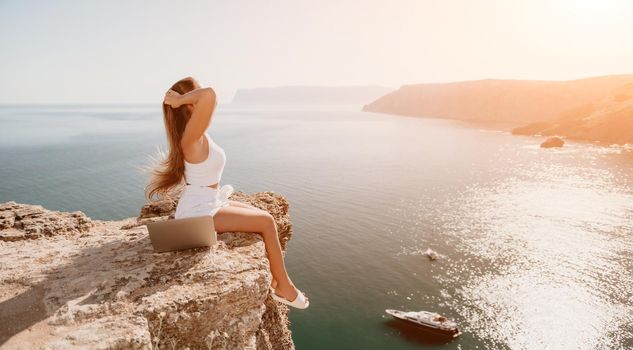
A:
[363,75,633,124]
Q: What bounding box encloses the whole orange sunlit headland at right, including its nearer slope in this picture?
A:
[363,75,633,144]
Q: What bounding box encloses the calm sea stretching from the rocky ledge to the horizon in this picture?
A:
[0,104,633,350]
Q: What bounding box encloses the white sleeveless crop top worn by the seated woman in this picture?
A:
[185,131,226,186]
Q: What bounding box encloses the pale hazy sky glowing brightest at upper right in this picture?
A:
[0,0,633,104]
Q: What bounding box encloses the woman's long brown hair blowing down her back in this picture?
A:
[144,77,199,203]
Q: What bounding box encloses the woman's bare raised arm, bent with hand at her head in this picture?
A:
[166,87,216,144]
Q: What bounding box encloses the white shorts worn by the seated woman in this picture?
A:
[174,185,233,219]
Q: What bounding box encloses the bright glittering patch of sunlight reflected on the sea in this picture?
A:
[424,154,633,349]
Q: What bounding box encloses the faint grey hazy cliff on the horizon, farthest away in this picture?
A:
[232,86,393,105]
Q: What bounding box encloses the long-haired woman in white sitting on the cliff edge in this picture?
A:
[145,77,309,309]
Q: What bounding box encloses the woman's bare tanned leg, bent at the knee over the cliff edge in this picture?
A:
[213,205,307,301]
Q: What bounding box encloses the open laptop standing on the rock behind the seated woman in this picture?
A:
[145,215,218,253]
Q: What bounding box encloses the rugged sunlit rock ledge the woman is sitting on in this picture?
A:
[0,192,294,349]
